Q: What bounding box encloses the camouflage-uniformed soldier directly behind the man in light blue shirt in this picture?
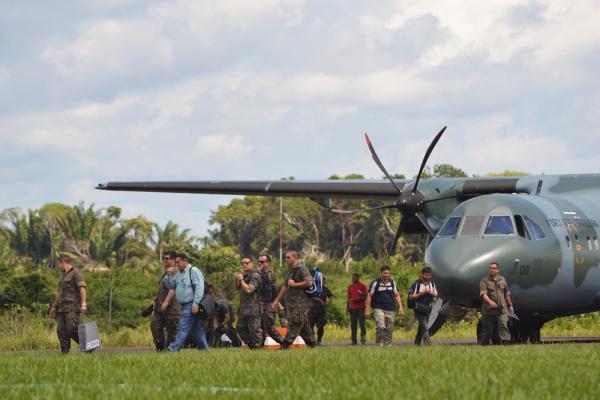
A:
[150,251,181,351]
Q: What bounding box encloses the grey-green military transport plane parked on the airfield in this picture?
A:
[97,127,600,342]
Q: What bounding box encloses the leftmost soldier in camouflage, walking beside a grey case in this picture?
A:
[50,256,87,354]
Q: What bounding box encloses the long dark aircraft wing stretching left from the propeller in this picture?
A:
[96,179,412,200]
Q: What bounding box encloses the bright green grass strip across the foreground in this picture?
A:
[0,344,600,399]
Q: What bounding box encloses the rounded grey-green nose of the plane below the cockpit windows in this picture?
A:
[425,238,493,307]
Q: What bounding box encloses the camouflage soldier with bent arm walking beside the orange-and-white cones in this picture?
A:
[271,251,315,349]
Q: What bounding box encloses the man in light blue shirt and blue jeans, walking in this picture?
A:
[165,253,208,351]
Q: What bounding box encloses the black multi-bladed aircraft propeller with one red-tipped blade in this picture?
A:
[332,127,446,257]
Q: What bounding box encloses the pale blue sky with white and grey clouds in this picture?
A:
[0,0,600,236]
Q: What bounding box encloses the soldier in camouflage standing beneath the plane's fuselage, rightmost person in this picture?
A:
[479,263,515,345]
